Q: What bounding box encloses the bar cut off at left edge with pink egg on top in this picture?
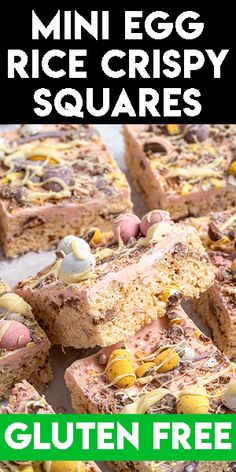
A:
[0,280,52,399]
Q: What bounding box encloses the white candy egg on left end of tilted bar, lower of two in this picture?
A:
[58,252,96,283]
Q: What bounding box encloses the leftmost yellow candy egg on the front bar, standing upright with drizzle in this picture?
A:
[106,349,136,388]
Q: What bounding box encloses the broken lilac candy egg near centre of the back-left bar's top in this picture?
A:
[43,165,75,192]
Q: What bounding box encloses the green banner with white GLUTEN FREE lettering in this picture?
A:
[0,415,236,461]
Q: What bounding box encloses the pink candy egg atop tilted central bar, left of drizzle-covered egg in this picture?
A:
[112,213,140,244]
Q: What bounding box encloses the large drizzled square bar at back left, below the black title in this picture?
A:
[0,125,132,257]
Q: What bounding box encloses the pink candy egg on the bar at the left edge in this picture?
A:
[0,320,31,351]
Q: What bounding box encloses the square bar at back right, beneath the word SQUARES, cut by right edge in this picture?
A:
[124,125,236,220]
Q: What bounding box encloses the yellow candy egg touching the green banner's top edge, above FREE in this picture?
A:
[177,385,209,415]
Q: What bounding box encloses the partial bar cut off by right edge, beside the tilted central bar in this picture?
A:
[189,209,236,359]
